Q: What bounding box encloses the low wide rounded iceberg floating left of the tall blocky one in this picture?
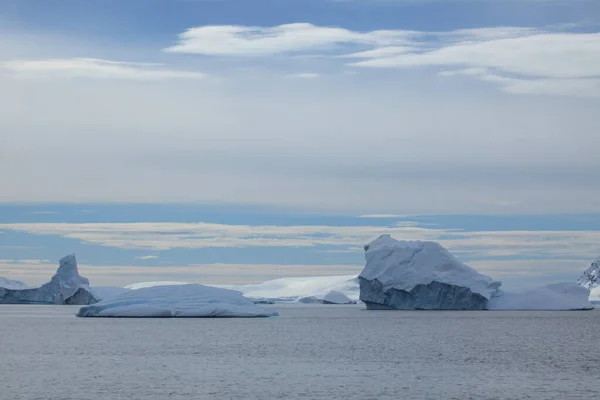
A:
[77,284,278,318]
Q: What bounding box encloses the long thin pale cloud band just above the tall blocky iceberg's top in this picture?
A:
[0,222,600,260]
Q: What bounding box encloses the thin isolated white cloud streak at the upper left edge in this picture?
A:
[0,58,204,80]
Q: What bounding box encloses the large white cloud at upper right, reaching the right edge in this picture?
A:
[349,28,600,97]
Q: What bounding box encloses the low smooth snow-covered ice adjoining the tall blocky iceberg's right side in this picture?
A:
[489,283,594,310]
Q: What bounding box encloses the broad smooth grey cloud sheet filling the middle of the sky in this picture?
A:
[0,25,600,215]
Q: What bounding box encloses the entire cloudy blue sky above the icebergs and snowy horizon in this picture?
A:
[0,0,600,294]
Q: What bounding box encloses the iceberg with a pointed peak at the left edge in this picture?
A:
[0,254,98,305]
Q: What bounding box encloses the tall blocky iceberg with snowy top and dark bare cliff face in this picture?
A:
[358,235,501,310]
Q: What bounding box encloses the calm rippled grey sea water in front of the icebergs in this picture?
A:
[0,305,600,400]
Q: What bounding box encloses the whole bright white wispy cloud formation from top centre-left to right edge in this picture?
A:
[165,23,600,96]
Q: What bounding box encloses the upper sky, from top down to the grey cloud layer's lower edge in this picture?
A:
[0,0,600,213]
